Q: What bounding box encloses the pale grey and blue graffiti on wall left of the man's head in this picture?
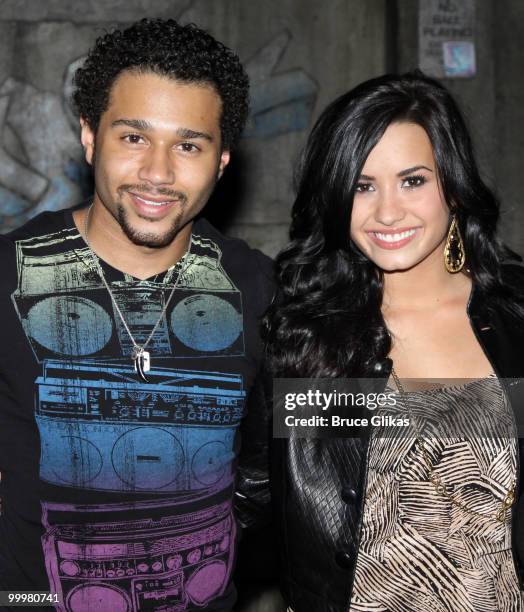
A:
[0,59,89,231]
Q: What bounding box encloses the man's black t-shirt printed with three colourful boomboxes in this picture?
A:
[0,210,272,612]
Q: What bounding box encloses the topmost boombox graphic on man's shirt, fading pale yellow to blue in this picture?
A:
[13,230,244,361]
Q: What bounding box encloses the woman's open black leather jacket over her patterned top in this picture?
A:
[238,265,524,612]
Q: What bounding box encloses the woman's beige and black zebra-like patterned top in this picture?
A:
[350,377,524,612]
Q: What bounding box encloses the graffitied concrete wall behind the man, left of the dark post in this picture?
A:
[0,0,386,254]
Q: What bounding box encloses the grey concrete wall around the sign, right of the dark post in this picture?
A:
[396,0,524,255]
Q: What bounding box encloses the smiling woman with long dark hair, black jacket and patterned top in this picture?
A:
[265,72,524,612]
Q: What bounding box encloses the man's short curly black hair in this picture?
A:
[73,19,249,150]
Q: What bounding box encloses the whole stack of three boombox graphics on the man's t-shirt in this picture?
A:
[13,229,250,612]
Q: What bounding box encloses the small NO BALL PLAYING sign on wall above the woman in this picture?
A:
[418,0,476,78]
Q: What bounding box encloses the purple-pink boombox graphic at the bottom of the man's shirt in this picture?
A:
[43,495,235,612]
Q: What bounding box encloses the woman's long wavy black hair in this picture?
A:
[263,71,506,378]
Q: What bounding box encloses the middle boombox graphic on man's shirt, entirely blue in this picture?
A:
[36,361,245,493]
